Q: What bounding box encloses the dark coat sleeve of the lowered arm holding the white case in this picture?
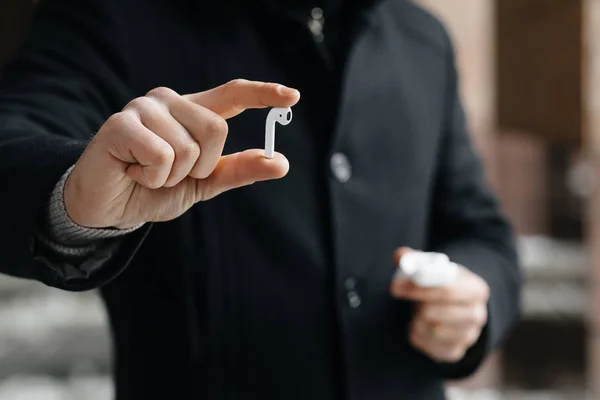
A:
[430,29,522,379]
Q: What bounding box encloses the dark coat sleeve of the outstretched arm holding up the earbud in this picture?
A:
[0,0,148,291]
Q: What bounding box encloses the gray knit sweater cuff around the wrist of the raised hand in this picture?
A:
[47,167,144,246]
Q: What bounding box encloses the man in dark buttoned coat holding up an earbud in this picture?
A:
[0,0,520,400]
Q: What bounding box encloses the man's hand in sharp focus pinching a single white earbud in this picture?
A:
[64,80,300,229]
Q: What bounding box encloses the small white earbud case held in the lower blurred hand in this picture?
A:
[397,251,458,287]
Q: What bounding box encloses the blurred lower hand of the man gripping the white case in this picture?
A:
[391,248,490,363]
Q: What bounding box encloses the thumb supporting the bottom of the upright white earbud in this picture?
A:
[196,149,290,201]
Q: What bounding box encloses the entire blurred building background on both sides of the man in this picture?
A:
[0,0,600,400]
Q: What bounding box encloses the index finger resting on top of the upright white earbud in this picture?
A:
[183,79,300,119]
